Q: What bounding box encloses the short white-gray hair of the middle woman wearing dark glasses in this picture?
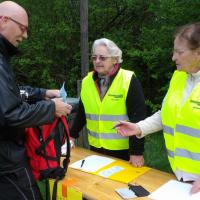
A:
[92,38,123,63]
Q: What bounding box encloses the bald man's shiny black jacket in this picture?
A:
[0,35,55,174]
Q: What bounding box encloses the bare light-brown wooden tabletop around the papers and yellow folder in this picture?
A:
[64,147,175,200]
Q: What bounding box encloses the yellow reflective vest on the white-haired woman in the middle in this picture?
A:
[81,69,133,150]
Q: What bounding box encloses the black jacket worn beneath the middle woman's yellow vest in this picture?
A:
[71,69,146,155]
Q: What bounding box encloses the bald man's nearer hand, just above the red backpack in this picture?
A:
[52,98,72,117]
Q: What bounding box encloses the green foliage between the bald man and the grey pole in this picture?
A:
[13,0,80,96]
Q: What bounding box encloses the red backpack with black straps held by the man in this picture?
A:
[25,116,70,180]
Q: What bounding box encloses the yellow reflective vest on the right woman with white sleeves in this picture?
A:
[161,71,200,175]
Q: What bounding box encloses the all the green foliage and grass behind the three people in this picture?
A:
[8,0,200,172]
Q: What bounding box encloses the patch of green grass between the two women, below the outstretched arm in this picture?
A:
[144,132,172,173]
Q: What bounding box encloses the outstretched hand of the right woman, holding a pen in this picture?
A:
[115,121,142,136]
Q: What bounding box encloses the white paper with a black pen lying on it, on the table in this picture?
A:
[69,155,115,172]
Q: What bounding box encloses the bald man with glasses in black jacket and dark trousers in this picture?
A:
[0,1,71,200]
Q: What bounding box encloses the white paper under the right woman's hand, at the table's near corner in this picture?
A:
[149,180,200,200]
